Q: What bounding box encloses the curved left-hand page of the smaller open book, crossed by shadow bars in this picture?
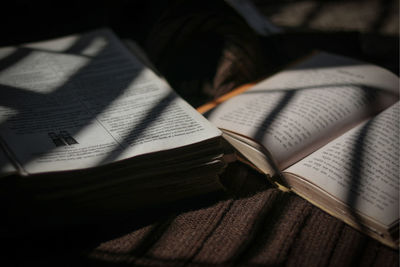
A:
[208,53,399,168]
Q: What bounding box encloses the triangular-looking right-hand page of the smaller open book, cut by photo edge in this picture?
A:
[285,102,400,225]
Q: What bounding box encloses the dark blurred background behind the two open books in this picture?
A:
[0,0,399,106]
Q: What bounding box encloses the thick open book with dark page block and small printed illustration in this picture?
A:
[0,29,224,223]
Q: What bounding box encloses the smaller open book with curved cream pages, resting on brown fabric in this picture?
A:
[199,52,400,247]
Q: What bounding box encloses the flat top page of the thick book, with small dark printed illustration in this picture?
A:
[0,30,221,173]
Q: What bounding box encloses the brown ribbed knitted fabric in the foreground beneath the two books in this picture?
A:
[2,163,399,267]
